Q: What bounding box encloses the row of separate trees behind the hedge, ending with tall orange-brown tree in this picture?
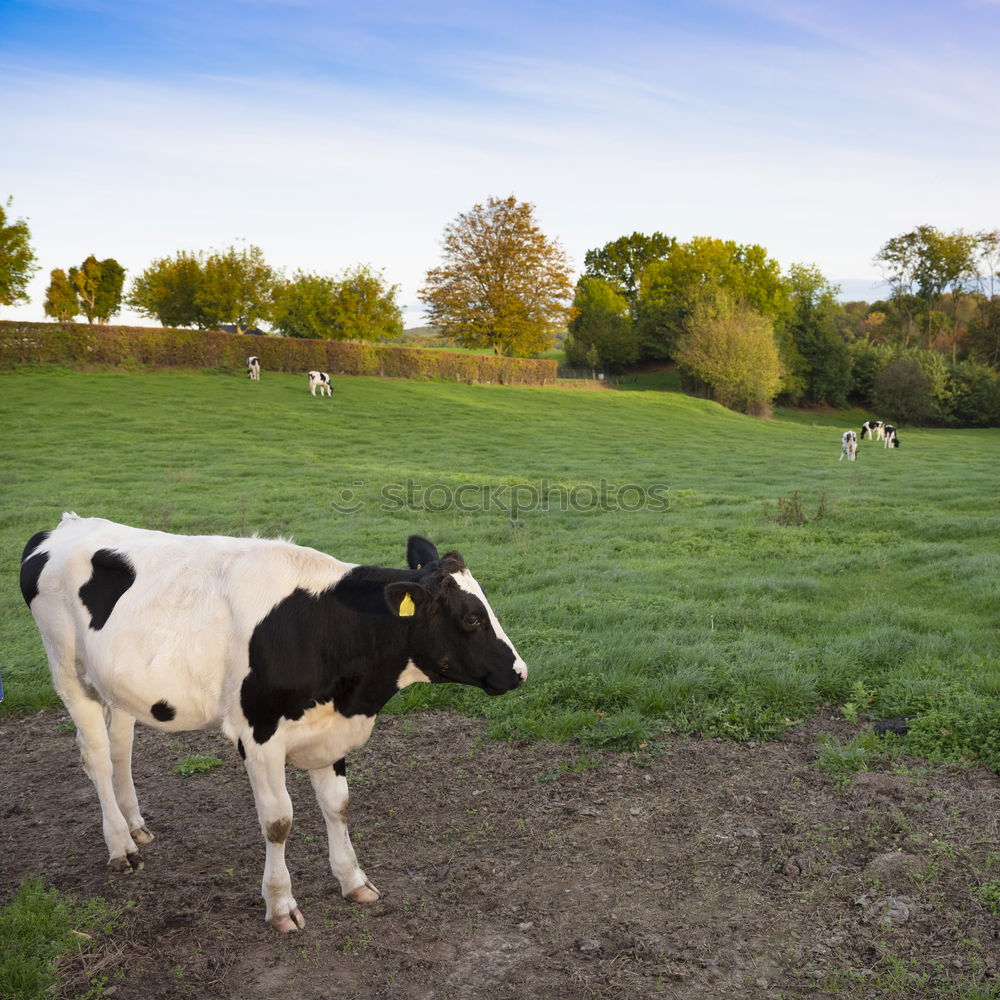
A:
[0,197,573,357]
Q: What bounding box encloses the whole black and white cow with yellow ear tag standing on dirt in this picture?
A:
[21,514,527,931]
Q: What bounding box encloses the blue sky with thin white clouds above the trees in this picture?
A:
[0,0,1000,325]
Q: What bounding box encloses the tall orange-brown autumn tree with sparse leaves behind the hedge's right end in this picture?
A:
[419,195,573,356]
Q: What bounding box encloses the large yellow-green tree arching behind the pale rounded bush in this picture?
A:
[638,236,788,357]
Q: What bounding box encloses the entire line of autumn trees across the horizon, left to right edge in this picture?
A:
[0,196,1000,425]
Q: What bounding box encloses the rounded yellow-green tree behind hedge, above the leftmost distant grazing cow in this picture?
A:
[195,246,278,333]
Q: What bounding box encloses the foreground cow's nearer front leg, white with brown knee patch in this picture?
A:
[244,737,306,934]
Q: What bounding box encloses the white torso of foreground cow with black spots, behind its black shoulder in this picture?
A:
[25,515,358,729]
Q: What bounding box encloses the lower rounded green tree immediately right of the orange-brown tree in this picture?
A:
[565,275,639,366]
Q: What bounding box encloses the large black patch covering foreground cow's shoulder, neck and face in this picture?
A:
[240,536,520,744]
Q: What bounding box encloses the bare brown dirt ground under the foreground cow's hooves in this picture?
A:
[0,712,1000,1000]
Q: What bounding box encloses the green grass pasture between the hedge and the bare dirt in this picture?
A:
[0,369,1000,768]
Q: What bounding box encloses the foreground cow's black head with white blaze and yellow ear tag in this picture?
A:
[385,535,528,694]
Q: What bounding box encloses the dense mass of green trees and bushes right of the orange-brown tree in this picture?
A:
[564,226,1000,425]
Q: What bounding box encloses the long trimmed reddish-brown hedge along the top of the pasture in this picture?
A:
[0,320,556,385]
